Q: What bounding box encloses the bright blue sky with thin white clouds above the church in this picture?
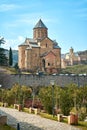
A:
[0,0,87,53]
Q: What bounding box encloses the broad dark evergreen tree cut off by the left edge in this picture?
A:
[0,37,8,66]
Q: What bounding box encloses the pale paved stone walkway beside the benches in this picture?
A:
[0,107,79,130]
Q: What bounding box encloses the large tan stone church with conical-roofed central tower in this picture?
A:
[18,19,61,73]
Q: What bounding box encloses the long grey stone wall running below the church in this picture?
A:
[3,74,87,88]
